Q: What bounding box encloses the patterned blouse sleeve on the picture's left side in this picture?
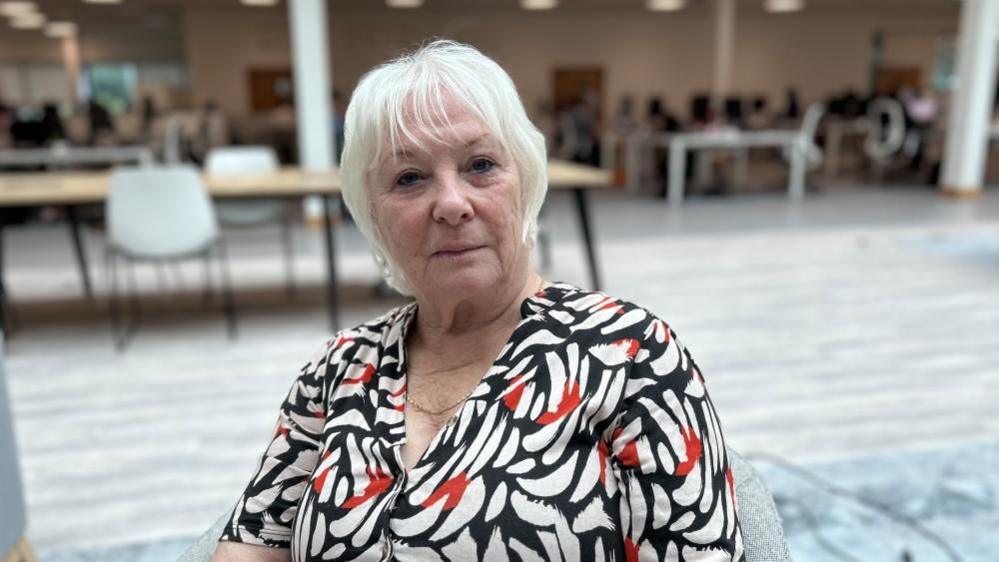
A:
[219,334,332,548]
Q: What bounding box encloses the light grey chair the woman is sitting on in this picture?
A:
[177,449,791,562]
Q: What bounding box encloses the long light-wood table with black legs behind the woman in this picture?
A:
[0,160,611,330]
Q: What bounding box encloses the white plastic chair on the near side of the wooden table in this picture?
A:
[105,166,236,349]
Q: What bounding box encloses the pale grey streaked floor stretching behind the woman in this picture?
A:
[4,185,999,562]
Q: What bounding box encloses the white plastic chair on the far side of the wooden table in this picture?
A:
[205,146,295,296]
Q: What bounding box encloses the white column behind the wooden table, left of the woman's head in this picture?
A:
[288,0,333,218]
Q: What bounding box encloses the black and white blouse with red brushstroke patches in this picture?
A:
[221,284,743,562]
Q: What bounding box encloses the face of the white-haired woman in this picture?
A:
[368,103,529,299]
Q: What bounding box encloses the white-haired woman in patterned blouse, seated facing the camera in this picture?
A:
[214,41,743,561]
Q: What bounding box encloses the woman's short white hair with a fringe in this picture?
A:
[340,40,548,295]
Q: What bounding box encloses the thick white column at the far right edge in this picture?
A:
[940,0,999,195]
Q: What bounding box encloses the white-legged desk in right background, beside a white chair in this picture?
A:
[667,130,809,206]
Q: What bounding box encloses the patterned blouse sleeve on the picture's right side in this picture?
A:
[610,320,744,562]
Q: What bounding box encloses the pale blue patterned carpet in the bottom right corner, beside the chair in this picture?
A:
[747,441,999,562]
